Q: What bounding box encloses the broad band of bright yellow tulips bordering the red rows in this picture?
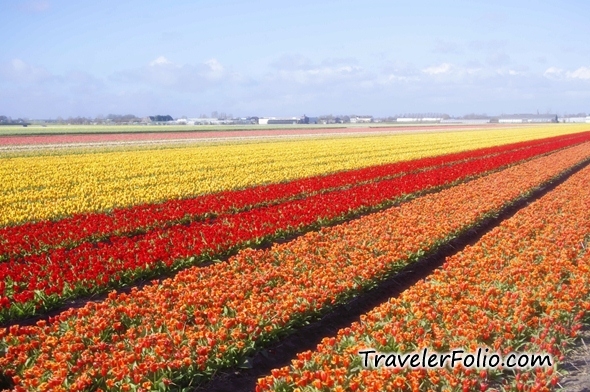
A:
[0,125,588,226]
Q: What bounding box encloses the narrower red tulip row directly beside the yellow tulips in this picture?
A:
[0,132,590,260]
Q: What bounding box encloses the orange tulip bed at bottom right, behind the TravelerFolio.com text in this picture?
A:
[257,148,590,391]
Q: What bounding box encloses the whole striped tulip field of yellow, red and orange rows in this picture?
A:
[0,124,590,391]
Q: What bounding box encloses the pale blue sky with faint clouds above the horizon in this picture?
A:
[0,0,590,118]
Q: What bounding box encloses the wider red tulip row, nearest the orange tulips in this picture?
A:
[0,139,588,321]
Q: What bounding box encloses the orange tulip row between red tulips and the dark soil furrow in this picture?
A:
[0,143,590,391]
